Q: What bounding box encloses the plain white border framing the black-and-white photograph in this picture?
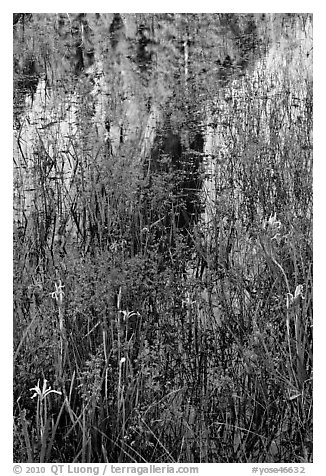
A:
[0,1,326,476]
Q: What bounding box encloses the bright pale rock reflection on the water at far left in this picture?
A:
[14,78,78,245]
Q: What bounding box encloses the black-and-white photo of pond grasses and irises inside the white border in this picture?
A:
[13,14,312,463]
